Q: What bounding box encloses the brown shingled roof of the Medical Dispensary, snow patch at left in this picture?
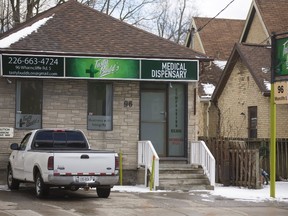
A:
[0,0,206,60]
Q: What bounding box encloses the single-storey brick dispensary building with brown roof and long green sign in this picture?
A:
[0,0,207,183]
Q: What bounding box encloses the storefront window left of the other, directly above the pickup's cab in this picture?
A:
[16,80,42,129]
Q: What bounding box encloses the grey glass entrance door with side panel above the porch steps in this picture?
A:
[140,83,186,157]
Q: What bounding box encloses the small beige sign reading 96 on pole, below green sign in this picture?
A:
[274,81,288,104]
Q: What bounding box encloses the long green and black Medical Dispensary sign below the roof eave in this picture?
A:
[1,54,199,81]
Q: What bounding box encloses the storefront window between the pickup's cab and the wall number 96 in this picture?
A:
[87,82,113,130]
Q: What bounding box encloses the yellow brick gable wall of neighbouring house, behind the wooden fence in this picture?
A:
[218,58,288,138]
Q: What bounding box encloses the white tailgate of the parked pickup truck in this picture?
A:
[54,151,115,175]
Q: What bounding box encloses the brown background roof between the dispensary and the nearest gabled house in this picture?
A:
[187,17,245,60]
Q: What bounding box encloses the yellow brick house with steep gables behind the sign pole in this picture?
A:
[210,0,288,138]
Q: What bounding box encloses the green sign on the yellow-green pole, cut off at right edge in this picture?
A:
[275,38,288,76]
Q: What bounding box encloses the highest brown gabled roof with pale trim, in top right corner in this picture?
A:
[241,0,288,42]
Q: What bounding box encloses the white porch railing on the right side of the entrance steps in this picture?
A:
[189,141,216,186]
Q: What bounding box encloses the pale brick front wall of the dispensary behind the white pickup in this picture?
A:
[0,78,197,177]
